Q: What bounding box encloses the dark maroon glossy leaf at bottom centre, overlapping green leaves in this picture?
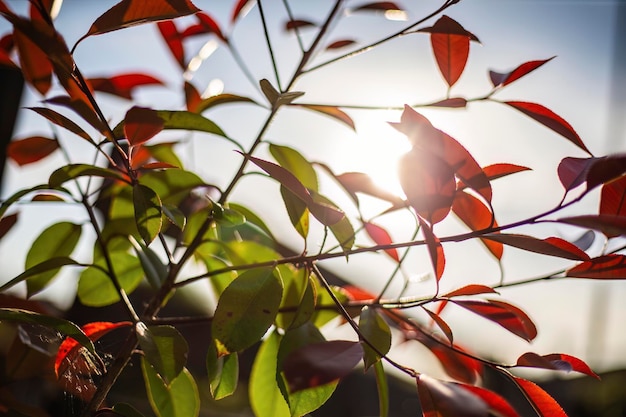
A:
[283,340,363,393]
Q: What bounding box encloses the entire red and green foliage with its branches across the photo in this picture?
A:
[0,0,626,417]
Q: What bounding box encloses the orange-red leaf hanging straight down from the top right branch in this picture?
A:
[418,15,479,87]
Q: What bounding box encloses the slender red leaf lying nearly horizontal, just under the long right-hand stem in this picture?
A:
[483,233,589,261]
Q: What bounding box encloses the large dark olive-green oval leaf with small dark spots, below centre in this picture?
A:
[211,268,283,355]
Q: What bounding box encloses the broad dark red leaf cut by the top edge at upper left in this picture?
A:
[76,0,200,44]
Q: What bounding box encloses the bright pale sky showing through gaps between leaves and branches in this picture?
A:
[0,0,626,372]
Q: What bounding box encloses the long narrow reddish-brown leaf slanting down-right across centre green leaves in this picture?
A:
[244,155,345,226]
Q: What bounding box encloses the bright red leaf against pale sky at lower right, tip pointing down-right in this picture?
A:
[450,299,537,342]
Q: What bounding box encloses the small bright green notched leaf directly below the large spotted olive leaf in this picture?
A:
[206,343,239,400]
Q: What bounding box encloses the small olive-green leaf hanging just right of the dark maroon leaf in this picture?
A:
[359,307,391,370]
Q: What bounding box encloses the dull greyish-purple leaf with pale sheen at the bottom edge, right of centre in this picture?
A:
[417,374,489,417]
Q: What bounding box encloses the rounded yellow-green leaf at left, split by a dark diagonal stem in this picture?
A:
[77,252,144,307]
